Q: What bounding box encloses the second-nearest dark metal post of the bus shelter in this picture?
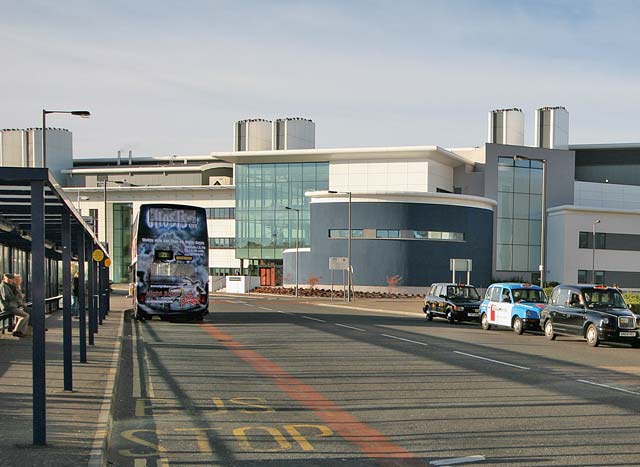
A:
[62,209,73,391]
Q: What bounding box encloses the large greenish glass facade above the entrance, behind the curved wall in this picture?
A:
[235,162,329,260]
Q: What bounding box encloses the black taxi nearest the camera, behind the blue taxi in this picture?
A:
[540,285,640,347]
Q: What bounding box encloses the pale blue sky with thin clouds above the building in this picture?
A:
[0,0,640,158]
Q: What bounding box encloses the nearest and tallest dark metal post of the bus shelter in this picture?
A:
[31,181,47,446]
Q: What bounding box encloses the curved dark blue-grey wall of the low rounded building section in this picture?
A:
[284,202,493,287]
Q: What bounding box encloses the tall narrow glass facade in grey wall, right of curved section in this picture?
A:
[496,157,542,272]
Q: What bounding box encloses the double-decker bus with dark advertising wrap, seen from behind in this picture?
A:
[131,204,209,320]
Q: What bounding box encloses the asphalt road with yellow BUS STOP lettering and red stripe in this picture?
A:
[109,296,640,467]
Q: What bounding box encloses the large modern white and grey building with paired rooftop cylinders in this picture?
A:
[2,107,640,291]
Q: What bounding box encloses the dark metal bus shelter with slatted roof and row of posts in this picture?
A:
[0,167,109,445]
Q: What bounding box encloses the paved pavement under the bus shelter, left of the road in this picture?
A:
[0,290,131,467]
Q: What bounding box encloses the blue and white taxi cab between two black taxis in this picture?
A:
[480,282,547,334]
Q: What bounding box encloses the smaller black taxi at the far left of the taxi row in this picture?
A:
[422,282,482,324]
